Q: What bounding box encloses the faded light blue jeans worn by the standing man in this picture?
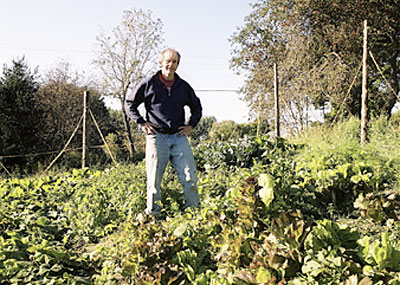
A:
[146,133,199,215]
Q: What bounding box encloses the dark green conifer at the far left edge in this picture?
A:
[0,58,43,169]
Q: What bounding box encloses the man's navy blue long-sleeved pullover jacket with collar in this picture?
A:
[125,71,202,132]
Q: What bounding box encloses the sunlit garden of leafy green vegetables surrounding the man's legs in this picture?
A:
[0,117,400,284]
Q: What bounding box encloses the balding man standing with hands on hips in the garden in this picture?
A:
[125,49,202,215]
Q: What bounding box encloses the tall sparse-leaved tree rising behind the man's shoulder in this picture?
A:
[94,9,163,158]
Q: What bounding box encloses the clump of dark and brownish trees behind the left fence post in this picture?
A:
[0,58,122,173]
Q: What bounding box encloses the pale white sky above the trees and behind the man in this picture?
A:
[0,0,253,122]
